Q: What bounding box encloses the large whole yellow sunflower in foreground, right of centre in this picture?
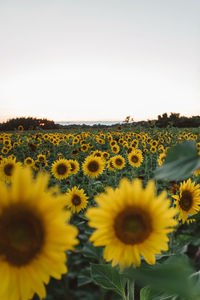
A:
[86,179,177,269]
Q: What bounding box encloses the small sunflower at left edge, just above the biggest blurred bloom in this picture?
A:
[0,157,21,183]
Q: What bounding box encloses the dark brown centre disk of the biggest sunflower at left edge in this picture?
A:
[0,205,44,267]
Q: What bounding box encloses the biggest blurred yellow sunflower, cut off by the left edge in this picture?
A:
[0,167,78,300]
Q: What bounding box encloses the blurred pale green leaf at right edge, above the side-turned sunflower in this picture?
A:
[154,141,200,180]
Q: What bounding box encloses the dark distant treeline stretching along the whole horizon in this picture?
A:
[0,113,200,131]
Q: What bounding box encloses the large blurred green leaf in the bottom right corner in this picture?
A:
[124,255,200,300]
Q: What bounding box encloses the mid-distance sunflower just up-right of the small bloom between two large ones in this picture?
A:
[82,155,105,178]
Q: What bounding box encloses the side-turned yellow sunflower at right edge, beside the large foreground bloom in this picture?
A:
[172,178,200,223]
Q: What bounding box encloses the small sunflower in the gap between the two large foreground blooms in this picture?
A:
[66,186,88,213]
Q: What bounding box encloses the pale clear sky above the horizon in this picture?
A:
[0,0,200,121]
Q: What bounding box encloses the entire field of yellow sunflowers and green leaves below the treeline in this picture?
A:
[0,126,200,300]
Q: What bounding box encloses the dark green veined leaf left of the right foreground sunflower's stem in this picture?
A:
[91,264,127,297]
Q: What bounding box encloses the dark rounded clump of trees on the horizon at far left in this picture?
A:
[0,117,61,131]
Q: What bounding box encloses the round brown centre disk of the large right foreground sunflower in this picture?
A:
[114,208,152,245]
